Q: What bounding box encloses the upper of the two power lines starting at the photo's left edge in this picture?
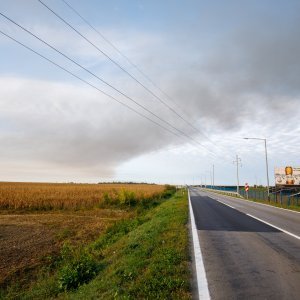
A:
[0,12,213,153]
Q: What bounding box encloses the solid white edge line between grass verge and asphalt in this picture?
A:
[188,189,210,300]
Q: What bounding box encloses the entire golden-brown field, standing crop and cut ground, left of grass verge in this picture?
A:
[0,182,173,290]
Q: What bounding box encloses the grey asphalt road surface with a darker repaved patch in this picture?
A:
[190,188,300,300]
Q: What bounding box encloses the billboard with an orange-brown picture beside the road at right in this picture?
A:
[275,166,300,186]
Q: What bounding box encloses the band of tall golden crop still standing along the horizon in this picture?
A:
[0,182,165,210]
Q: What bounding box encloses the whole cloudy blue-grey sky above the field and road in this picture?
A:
[0,0,300,185]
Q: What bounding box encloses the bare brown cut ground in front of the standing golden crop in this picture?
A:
[0,209,129,285]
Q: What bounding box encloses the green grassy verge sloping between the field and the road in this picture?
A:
[0,191,191,299]
